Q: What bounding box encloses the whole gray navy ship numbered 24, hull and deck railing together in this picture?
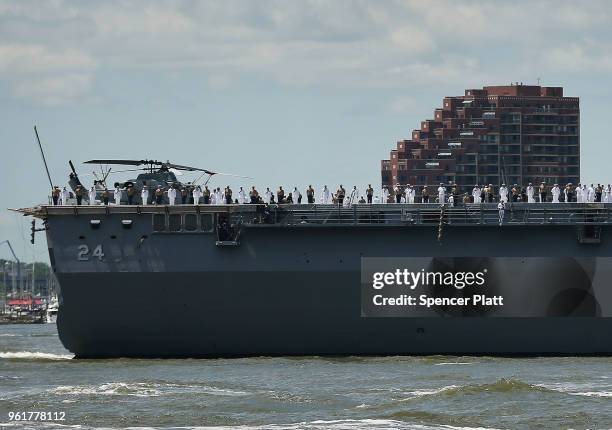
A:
[13,195,612,358]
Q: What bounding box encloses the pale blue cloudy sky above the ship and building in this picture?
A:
[0,0,612,261]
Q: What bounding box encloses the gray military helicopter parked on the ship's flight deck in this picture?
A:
[68,159,252,204]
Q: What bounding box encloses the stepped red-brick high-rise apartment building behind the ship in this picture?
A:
[381,83,580,191]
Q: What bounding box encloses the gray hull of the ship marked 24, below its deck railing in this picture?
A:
[32,204,612,358]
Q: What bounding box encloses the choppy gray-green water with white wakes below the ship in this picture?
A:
[0,325,612,429]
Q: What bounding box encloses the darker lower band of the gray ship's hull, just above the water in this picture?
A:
[58,272,612,358]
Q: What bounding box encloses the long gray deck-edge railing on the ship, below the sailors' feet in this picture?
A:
[17,203,612,226]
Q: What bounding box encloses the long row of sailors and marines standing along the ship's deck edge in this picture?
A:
[51,183,612,206]
